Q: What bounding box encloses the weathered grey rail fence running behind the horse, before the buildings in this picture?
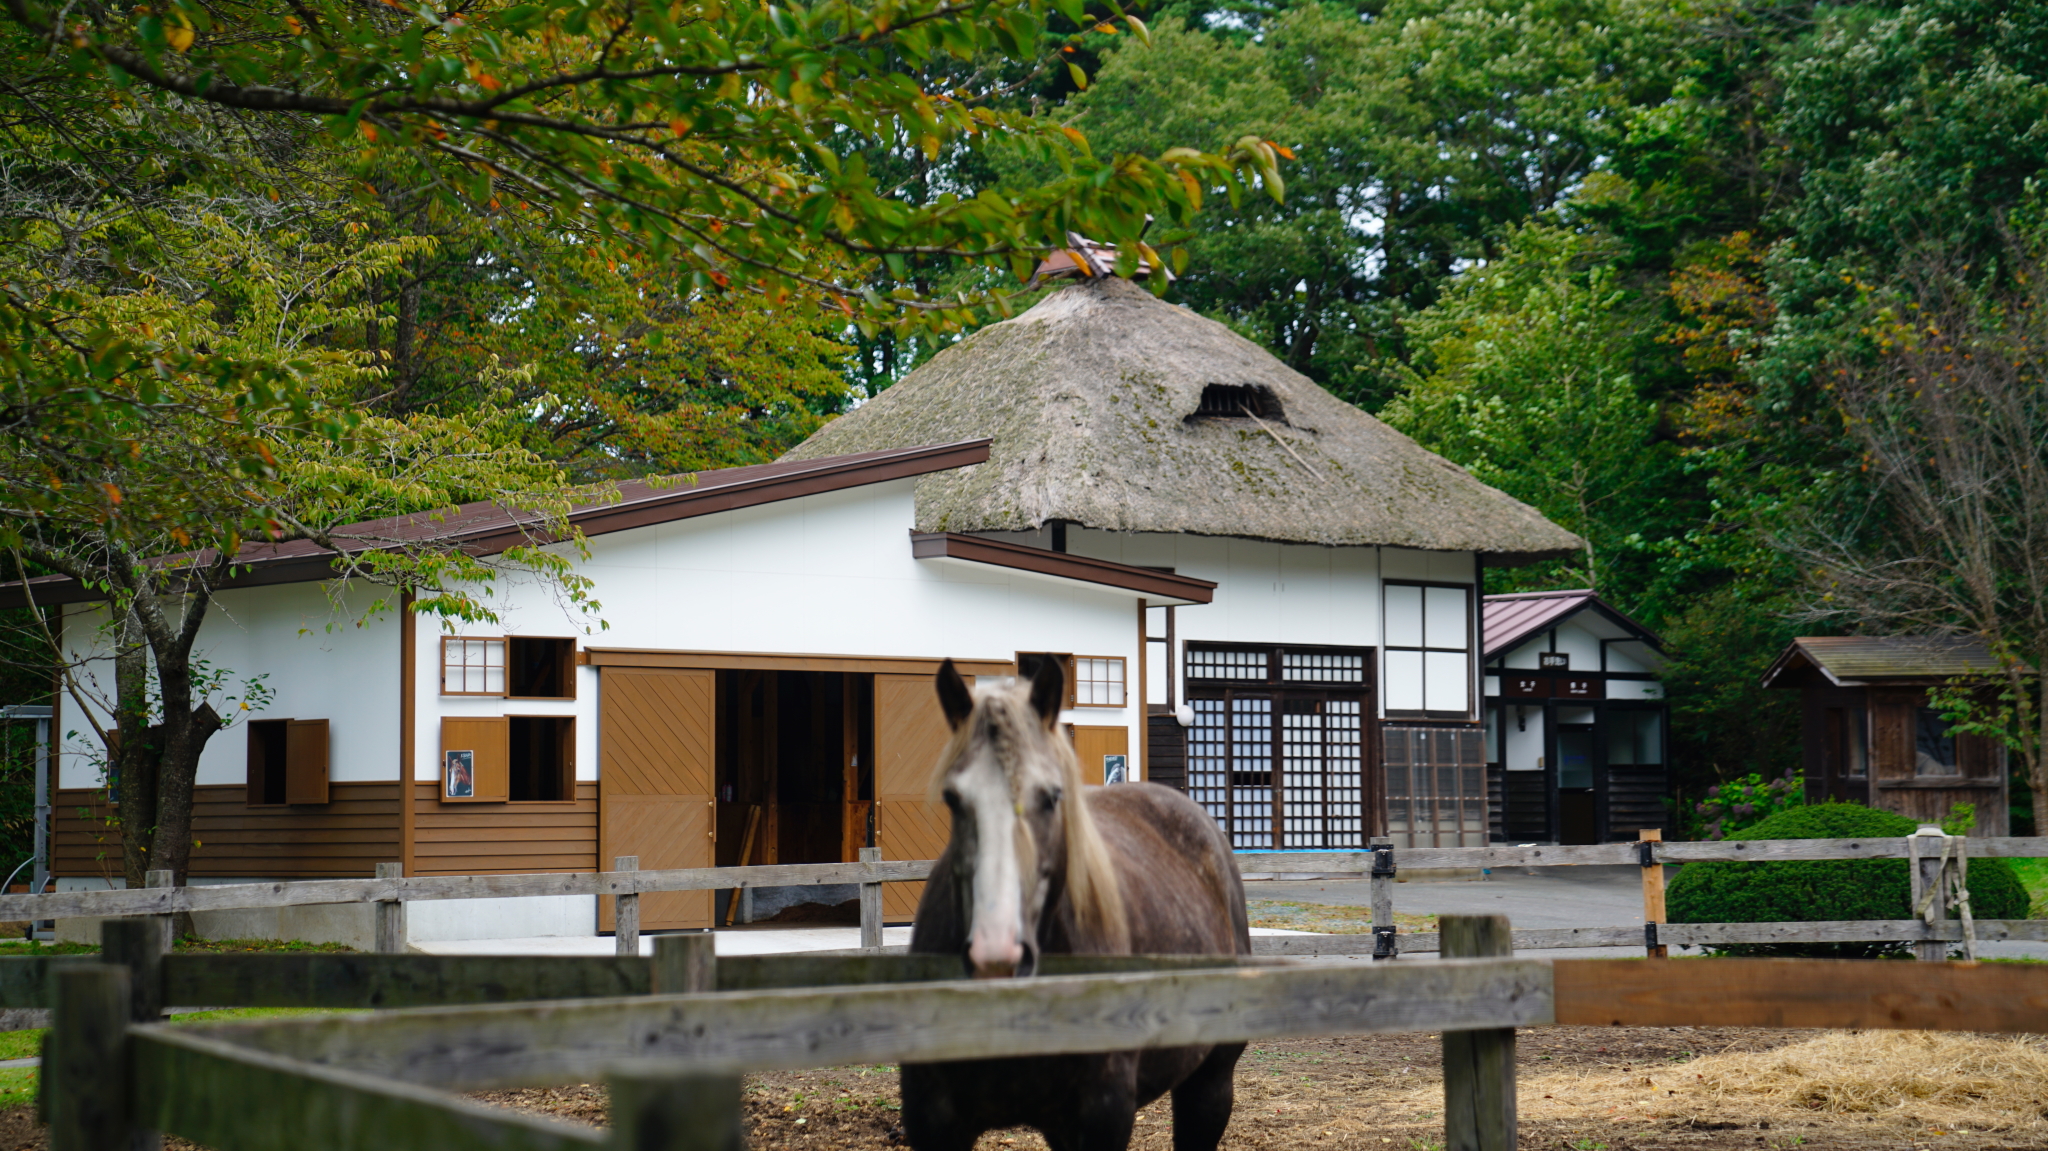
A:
[19,832,2048,961]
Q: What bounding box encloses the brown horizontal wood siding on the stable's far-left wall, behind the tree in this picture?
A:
[51,780,399,879]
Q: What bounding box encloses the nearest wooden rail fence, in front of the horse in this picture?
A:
[32,915,2048,1151]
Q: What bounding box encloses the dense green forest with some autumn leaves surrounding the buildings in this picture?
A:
[0,0,2048,872]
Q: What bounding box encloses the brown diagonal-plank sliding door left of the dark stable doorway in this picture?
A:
[598,668,717,930]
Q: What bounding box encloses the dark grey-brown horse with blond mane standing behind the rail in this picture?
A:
[901,659,1251,1151]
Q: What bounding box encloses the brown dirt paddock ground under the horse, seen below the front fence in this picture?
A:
[471,1028,2048,1151]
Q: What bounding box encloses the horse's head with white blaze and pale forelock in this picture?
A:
[938,659,1124,977]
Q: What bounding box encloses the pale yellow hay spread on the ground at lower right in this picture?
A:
[1520,1030,2048,1131]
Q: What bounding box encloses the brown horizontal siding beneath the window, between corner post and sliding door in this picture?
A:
[412,780,598,875]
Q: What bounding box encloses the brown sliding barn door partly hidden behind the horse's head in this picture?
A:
[874,676,952,920]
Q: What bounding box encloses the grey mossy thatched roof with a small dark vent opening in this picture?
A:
[782,279,1585,563]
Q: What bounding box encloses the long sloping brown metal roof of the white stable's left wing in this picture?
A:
[0,440,989,608]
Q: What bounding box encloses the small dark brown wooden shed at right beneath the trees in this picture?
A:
[1763,635,2009,836]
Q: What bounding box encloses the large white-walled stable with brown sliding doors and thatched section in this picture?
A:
[8,281,1581,940]
